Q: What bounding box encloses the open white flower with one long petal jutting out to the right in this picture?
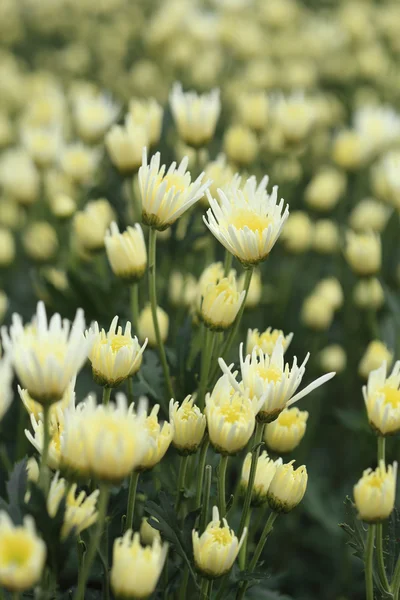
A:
[218,337,335,423]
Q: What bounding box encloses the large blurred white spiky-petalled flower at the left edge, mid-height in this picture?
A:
[2,302,92,404]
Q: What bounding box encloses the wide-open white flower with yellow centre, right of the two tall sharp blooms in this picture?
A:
[203,177,289,265]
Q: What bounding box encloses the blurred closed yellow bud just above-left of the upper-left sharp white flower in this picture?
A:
[105,115,149,175]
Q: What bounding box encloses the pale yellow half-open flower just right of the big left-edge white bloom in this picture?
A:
[86,316,147,387]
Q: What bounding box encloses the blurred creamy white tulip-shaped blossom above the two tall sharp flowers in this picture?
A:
[169,83,221,147]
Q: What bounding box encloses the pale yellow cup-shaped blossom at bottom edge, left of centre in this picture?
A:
[111,529,168,600]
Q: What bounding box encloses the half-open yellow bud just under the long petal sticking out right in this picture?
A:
[264,406,308,454]
